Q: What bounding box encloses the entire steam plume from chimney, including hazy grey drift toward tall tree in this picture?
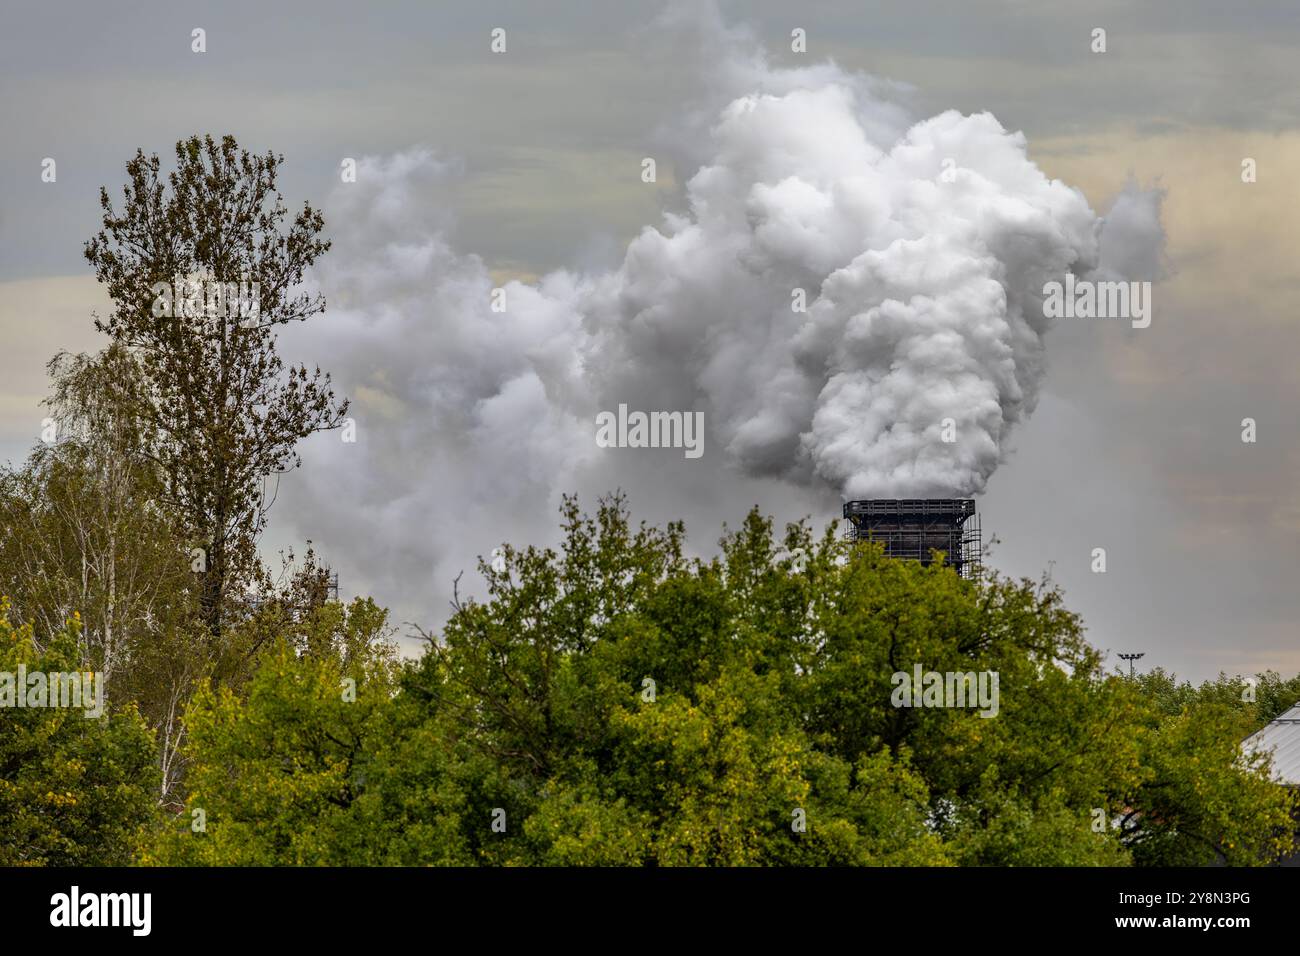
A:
[276,9,1160,629]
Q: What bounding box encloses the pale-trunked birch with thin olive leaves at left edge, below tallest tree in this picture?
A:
[0,346,196,685]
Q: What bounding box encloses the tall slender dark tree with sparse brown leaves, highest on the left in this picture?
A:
[86,137,347,637]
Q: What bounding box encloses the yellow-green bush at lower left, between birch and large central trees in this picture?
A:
[147,598,395,865]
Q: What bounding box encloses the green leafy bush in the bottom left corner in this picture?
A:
[0,601,159,866]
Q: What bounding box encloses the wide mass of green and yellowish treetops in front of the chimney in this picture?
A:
[142,499,1294,866]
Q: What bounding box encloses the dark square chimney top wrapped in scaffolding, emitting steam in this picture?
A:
[844,498,982,578]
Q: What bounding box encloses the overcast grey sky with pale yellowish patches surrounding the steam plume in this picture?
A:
[0,0,1300,678]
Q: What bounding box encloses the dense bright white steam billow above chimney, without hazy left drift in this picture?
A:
[577,100,1099,497]
